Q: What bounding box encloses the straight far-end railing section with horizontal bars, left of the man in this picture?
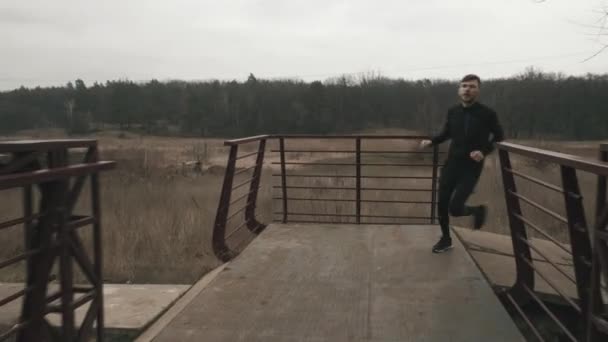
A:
[271,135,441,224]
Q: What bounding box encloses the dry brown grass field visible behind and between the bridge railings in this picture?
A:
[0,131,599,283]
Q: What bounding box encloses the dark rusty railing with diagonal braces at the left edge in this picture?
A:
[0,140,114,342]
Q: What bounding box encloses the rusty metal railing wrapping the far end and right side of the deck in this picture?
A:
[213,135,608,341]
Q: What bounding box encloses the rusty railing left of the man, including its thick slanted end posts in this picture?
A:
[213,135,443,261]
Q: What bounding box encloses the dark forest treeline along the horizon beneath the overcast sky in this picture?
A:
[0,68,608,139]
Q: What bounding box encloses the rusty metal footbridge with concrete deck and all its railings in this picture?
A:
[0,135,608,341]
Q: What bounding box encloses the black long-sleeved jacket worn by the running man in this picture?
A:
[431,102,504,159]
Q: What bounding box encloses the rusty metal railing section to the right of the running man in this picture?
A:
[498,143,608,341]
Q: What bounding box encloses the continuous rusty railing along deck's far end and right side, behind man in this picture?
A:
[214,134,608,342]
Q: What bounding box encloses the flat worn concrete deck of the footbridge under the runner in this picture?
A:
[139,224,524,342]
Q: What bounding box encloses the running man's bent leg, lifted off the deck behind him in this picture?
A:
[449,165,486,229]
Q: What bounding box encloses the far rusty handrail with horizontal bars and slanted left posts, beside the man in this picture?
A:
[213,134,442,261]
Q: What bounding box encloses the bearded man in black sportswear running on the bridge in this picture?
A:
[420,75,504,253]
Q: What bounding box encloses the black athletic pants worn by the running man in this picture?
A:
[437,158,483,237]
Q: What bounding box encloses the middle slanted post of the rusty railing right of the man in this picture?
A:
[560,165,592,340]
